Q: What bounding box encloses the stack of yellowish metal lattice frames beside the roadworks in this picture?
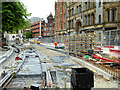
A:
[66,33,99,55]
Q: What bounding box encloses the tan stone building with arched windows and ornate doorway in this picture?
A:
[66,0,120,45]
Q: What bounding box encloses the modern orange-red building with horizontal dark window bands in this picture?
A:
[30,20,45,37]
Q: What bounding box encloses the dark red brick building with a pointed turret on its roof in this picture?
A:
[44,14,55,37]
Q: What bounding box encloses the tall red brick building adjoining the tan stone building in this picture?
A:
[55,0,67,42]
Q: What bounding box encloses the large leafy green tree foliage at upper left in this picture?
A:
[2,2,30,32]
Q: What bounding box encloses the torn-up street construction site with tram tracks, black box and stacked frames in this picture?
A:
[0,33,120,90]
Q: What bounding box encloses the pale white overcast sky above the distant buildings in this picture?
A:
[20,0,57,20]
